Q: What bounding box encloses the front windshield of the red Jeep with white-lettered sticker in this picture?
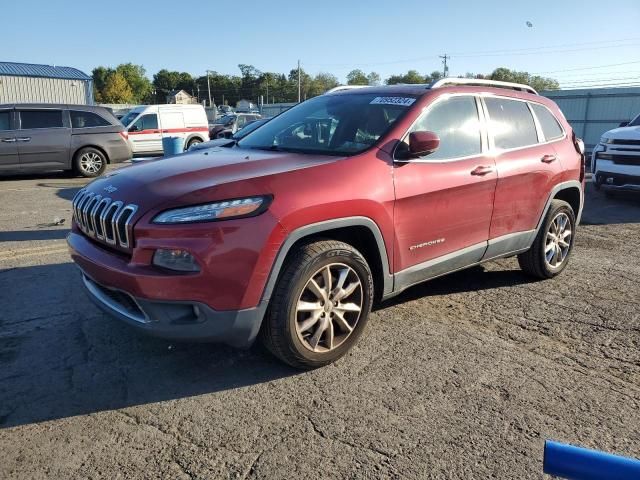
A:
[238,93,417,155]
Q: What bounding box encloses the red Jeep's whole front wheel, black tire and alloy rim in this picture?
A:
[260,240,373,370]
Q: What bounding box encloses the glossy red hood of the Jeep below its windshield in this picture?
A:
[86,147,342,214]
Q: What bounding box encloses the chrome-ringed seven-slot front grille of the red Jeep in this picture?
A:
[72,189,138,249]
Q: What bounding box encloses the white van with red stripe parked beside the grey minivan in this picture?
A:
[121,105,209,155]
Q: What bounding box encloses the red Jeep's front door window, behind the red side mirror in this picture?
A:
[399,97,482,160]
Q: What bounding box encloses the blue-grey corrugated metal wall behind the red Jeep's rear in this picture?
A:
[541,88,640,151]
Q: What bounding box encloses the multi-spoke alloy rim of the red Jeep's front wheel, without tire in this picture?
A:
[296,263,363,352]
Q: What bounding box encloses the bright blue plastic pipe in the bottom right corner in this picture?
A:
[543,440,640,480]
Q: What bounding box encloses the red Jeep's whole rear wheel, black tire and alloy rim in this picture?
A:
[518,200,576,279]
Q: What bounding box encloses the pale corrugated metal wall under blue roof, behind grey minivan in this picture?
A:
[0,75,93,105]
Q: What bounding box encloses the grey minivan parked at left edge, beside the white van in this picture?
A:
[0,103,132,177]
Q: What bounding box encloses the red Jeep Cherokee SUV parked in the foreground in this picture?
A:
[68,79,584,368]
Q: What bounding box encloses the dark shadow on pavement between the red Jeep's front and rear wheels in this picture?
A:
[375,265,538,310]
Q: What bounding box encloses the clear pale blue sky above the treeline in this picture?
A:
[0,0,640,88]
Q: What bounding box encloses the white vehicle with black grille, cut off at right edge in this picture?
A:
[591,115,640,191]
